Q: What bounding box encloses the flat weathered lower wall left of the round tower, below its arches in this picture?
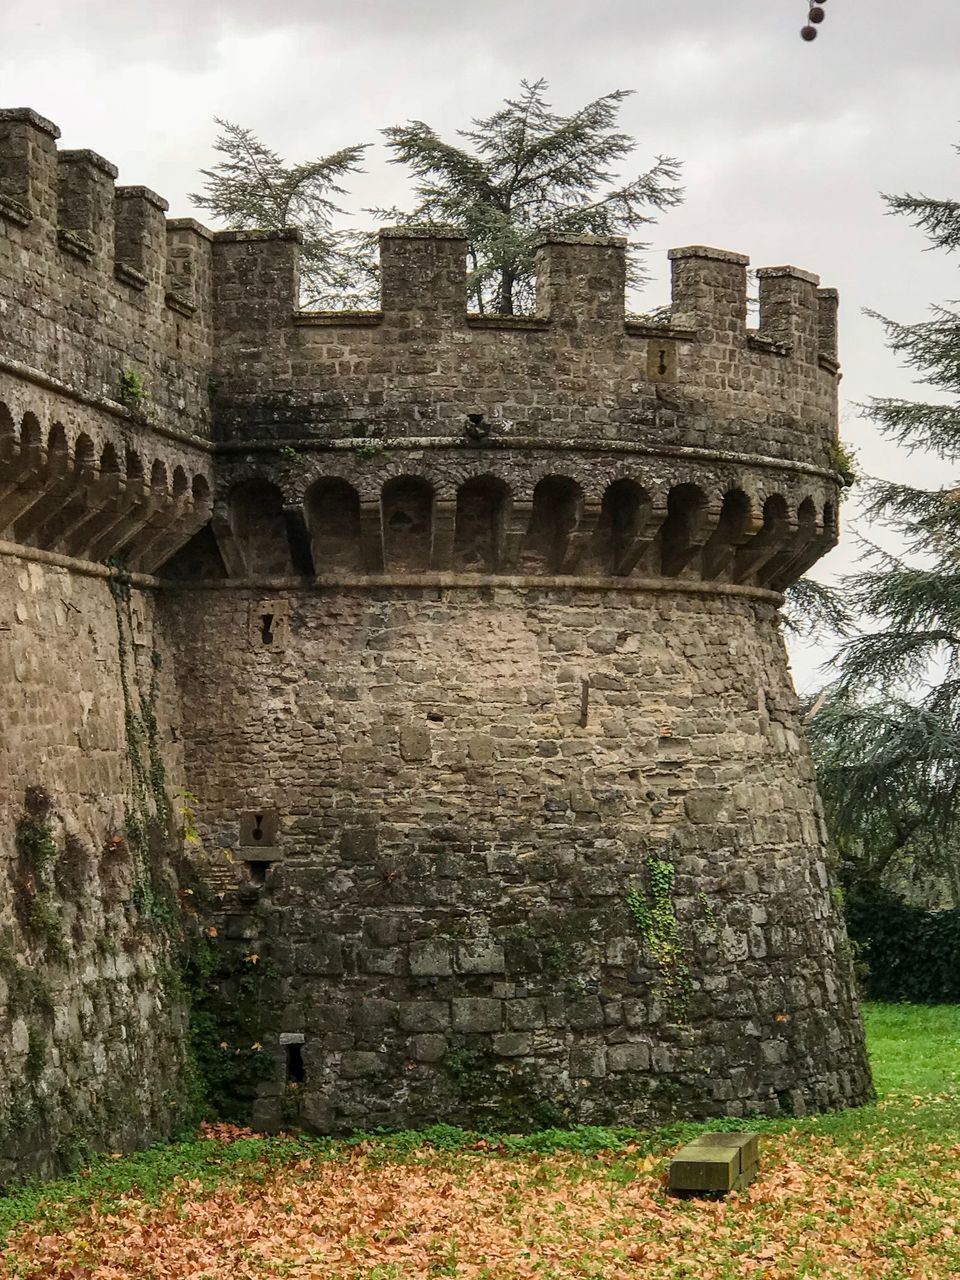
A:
[0,552,189,1181]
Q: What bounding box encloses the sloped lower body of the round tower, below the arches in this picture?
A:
[165,584,869,1132]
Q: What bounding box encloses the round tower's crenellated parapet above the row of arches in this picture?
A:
[214,232,837,467]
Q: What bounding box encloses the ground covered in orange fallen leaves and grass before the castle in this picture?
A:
[0,1006,960,1280]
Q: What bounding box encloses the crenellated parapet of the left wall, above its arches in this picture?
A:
[0,109,212,436]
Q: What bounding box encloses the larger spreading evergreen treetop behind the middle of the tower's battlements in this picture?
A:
[374,79,682,315]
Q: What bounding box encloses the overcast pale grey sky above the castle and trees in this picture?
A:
[0,0,960,687]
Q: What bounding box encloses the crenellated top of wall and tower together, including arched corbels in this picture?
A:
[0,109,837,585]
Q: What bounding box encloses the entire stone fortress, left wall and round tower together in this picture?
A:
[0,109,869,1174]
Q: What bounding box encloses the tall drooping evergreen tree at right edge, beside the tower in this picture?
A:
[810,137,960,901]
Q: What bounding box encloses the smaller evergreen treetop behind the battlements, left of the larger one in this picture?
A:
[189,118,376,310]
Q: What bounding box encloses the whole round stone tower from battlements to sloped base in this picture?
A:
[154,229,869,1130]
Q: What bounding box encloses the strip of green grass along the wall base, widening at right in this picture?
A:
[0,1005,960,1242]
